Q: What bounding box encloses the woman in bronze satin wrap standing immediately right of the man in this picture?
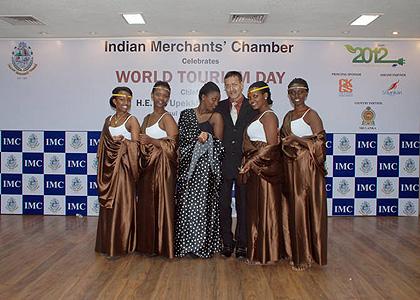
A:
[240,81,286,264]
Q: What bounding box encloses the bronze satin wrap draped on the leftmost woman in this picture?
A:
[95,119,138,256]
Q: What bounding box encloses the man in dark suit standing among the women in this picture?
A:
[216,71,258,258]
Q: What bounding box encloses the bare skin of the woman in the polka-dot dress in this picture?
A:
[194,91,223,143]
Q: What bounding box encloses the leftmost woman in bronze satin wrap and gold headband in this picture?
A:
[95,87,140,257]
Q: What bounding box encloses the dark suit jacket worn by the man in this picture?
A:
[216,97,258,179]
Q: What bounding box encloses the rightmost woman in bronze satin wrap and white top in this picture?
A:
[281,78,327,270]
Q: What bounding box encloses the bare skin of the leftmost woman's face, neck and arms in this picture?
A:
[109,91,140,141]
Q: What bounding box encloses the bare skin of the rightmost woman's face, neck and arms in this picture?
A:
[282,84,324,148]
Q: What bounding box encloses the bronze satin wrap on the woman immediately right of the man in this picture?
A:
[240,133,290,264]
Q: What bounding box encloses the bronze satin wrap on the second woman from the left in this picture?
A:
[136,132,178,258]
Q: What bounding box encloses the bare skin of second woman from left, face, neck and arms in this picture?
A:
[139,86,178,148]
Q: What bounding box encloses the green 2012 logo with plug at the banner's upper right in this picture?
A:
[344,44,406,67]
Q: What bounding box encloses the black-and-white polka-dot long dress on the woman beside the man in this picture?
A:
[175,109,224,258]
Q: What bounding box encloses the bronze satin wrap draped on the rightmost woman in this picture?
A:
[281,112,327,269]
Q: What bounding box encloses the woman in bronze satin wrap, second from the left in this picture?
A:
[136,81,178,258]
